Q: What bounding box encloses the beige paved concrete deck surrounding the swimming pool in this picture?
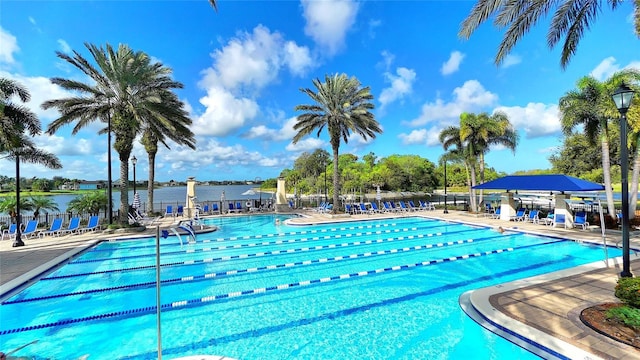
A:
[0,210,640,359]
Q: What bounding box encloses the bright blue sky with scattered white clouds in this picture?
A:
[0,0,640,181]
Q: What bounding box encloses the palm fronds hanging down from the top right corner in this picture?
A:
[458,0,640,69]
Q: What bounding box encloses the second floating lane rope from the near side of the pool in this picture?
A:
[10,234,515,305]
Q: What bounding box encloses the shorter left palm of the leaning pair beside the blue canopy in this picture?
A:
[439,126,476,209]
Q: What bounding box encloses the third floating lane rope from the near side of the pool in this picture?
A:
[50,229,478,280]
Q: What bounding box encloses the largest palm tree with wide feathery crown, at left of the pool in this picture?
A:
[42,43,190,223]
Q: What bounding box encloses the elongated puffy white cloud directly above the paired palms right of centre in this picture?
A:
[409,80,498,127]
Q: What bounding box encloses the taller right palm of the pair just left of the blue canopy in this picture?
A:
[460,111,518,211]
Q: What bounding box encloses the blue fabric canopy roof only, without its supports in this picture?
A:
[473,175,604,191]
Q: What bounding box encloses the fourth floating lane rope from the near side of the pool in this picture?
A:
[69,227,476,265]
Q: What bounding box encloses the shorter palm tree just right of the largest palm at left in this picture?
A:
[140,91,196,213]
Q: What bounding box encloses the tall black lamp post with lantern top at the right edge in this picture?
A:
[611,83,634,277]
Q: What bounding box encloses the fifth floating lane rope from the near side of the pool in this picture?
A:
[89,220,442,252]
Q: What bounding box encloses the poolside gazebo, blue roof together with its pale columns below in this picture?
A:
[473,174,604,226]
